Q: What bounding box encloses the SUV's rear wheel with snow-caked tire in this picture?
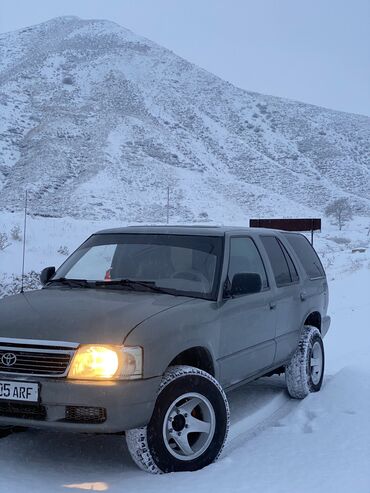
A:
[285,325,325,399]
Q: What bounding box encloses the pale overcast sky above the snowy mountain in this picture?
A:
[0,0,370,115]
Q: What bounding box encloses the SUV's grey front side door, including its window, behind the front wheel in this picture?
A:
[219,236,276,387]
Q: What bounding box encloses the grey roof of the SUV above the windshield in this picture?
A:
[95,225,284,236]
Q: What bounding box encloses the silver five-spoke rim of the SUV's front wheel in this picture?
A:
[163,392,216,461]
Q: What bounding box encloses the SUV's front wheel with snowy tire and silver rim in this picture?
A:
[126,366,230,473]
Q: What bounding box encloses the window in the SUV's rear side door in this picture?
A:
[261,236,298,287]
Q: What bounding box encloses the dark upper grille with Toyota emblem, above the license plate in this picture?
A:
[0,345,73,376]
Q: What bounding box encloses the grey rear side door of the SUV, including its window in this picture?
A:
[260,235,302,365]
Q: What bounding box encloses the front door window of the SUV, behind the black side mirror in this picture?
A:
[229,237,269,290]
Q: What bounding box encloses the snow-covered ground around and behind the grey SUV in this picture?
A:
[0,214,370,493]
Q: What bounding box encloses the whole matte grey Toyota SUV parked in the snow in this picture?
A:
[0,226,330,473]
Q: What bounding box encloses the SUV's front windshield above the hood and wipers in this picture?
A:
[53,233,223,299]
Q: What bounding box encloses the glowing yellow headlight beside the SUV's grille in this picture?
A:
[68,345,143,380]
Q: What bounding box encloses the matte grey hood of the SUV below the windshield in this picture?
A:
[0,288,191,344]
